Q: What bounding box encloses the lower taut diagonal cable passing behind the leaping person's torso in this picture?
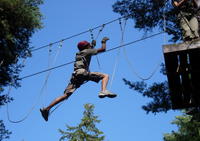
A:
[19,31,165,80]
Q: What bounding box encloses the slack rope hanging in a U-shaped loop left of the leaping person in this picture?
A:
[6,42,62,123]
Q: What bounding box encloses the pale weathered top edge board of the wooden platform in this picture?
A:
[163,38,200,53]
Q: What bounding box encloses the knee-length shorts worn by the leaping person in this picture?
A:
[64,69,105,94]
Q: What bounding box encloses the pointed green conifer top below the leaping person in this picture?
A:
[59,104,105,141]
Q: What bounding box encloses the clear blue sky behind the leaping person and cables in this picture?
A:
[0,0,181,141]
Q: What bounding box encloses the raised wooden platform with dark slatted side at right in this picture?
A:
[163,39,200,109]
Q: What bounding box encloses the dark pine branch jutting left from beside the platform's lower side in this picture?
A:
[123,79,172,114]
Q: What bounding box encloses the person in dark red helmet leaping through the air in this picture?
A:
[40,37,117,121]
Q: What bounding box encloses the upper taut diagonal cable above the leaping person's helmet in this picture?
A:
[31,14,132,52]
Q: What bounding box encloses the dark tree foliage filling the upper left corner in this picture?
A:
[0,0,42,89]
